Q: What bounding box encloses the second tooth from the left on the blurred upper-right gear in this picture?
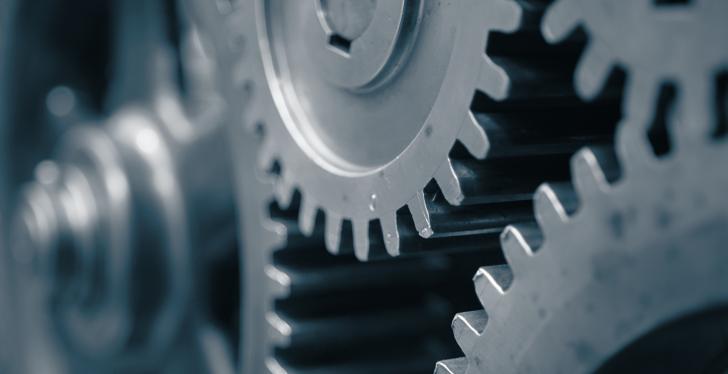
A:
[575,40,613,100]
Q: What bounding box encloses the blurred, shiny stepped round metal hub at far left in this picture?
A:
[11,110,185,369]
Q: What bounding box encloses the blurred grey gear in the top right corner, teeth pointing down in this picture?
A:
[542,0,728,149]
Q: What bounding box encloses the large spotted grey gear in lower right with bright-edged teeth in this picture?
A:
[436,35,728,373]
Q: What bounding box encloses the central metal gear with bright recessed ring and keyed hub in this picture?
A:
[241,0,521,259]
